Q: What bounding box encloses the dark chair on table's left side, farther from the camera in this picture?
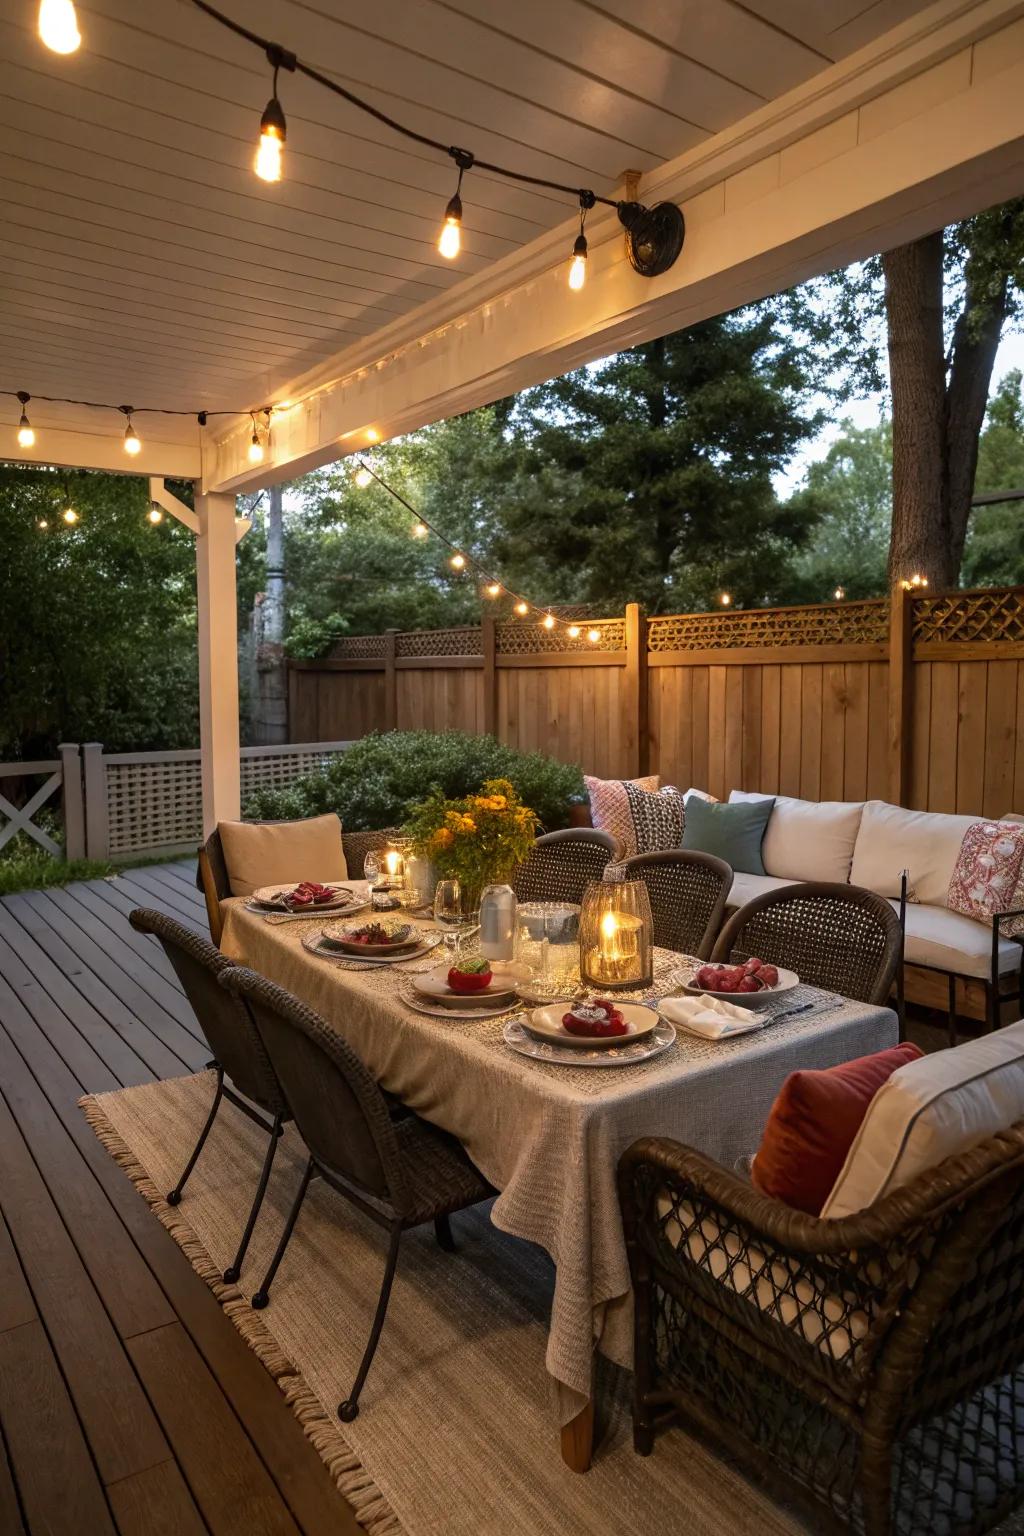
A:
[127,906,292,1284]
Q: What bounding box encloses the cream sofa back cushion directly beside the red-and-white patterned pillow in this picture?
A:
[851,800,978,906]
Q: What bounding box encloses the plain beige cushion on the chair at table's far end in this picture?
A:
[216,813,348,895]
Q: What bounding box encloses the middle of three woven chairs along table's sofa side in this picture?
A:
[623,848,732,960]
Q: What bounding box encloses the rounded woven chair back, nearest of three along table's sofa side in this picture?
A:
[711,882,903,1003]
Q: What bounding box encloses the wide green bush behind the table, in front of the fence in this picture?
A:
[244,731,586,833]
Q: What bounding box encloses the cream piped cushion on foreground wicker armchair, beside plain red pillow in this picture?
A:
[821,1020,1024,1217]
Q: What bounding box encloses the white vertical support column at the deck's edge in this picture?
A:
[195,487,241,837]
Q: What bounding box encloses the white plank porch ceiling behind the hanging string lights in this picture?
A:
[0,0,945,445]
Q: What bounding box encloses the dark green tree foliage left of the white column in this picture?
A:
[0,467,198,759]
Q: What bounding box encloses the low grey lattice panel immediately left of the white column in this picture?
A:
[104,753,203,854]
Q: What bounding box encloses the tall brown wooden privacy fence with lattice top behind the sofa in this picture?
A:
[289,588,1024,816]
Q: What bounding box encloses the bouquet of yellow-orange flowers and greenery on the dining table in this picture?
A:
[402,779,537,894]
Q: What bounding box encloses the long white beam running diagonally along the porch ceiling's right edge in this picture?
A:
[204,0,1024,490]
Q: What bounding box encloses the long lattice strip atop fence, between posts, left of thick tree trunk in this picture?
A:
[648,599,889,651]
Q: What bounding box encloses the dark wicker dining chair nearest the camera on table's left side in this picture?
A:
[220,966,494,1424]
